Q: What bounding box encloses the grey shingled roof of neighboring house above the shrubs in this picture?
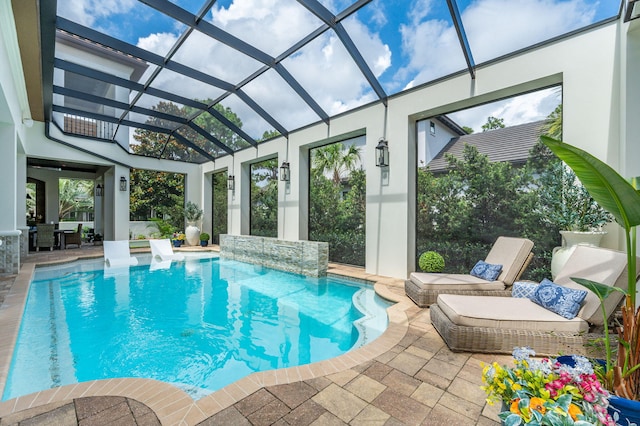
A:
[427,120,545,173]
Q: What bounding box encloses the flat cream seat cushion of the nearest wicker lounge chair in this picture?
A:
[437,294,589,333]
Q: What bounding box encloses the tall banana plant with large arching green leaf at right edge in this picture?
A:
[541,136,640,400]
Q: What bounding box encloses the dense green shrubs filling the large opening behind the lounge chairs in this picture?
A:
[416,106,607,280]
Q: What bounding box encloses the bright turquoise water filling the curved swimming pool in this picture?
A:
[3,256,389,400]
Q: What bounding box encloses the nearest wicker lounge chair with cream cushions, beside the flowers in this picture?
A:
[429,246,639,355]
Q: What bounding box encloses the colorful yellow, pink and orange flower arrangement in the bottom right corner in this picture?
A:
[482,348,615,426]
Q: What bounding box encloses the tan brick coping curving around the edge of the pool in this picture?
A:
[0,251,412,425]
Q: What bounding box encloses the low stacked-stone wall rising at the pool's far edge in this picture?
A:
[220,234,329,277]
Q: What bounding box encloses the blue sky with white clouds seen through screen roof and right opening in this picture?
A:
[58,0,620,136]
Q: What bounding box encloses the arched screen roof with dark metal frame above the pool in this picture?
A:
[30,0,626,163]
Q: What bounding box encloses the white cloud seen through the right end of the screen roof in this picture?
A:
[395,0,595,87]
